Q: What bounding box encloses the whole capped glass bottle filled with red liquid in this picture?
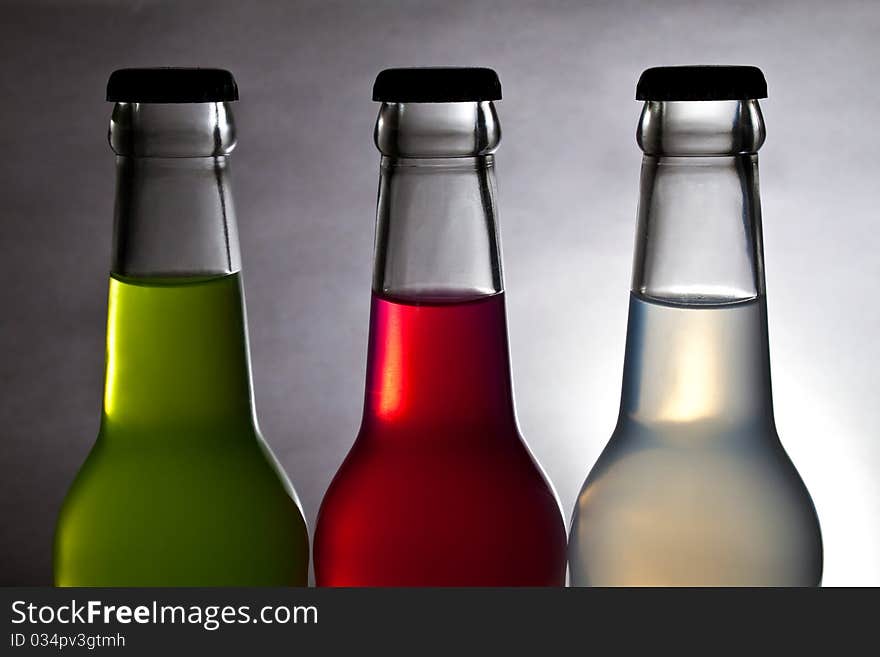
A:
[314,68,566,586]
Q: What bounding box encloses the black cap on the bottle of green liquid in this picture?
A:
[107,68,238,103]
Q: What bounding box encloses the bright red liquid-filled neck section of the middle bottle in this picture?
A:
[362,293,516,434]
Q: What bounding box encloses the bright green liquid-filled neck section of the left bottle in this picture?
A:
[102,274,255,441]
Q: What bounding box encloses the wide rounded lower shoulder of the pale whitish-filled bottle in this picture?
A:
[569,416,822,586]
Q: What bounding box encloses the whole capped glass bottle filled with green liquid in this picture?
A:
[55,69,308,586]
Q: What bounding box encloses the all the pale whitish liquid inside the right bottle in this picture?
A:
[570,293,822,586]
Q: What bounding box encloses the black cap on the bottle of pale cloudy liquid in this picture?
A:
[636,66,767,100]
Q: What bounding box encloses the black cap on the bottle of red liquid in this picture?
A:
[373,67,501,103]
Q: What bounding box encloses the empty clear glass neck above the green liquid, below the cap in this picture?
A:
[110,103,241,278]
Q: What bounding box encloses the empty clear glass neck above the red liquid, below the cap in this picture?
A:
[373,102,502,302]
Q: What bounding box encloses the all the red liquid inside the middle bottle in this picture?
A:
[314,294,566,586]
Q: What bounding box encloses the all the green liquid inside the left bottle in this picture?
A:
[55,274,309,586]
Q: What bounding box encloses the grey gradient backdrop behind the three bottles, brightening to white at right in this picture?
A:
[0,0,880,585]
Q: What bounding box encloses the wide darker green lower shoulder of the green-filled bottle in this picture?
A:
[55,434,309,586]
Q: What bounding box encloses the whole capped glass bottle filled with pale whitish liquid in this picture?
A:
[569,66,822,586]
